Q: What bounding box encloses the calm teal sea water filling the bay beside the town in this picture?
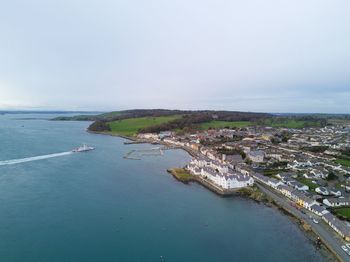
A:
[0,115,323,262]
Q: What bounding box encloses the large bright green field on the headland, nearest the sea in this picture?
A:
[108,115,181,136]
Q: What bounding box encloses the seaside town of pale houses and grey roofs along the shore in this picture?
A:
[138,124,350,256]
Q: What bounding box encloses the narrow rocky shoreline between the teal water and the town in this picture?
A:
[87,130,343,261]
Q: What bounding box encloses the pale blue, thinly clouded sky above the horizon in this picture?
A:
[0,0,350,113]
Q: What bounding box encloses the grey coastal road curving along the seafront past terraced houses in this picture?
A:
[256,183,350,262]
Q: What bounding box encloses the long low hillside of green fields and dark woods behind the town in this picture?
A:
[53,109,334,136]
